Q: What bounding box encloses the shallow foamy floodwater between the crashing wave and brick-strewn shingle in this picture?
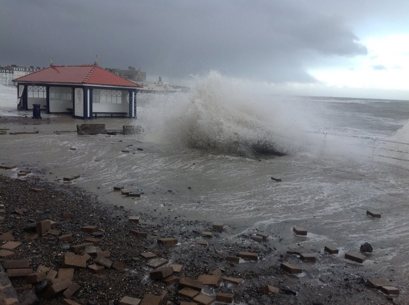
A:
[0,112,409,302]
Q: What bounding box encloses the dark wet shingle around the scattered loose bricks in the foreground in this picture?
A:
[0,175,405,305]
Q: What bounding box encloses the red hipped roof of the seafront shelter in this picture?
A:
[14,65,137,87]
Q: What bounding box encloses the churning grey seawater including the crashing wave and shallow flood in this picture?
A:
[0,73,409,292]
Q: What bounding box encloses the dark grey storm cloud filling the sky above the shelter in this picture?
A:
[0,0,366,81]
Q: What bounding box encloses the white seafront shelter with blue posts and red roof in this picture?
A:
[14,64,139,119]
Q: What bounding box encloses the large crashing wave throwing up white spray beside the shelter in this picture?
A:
[139,72,305,156]
